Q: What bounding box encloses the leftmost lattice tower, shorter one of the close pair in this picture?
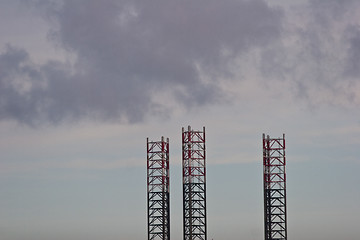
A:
[147,137,170,240]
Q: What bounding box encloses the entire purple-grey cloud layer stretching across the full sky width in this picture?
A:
[0,0,360,125]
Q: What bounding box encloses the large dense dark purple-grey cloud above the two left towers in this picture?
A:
[0,0,282,124]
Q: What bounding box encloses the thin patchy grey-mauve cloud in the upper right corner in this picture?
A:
[260,0,360,106]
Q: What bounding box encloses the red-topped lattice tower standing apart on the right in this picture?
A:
[263,134,287,240]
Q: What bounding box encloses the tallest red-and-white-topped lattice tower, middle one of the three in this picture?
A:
[182,126,207,240]
